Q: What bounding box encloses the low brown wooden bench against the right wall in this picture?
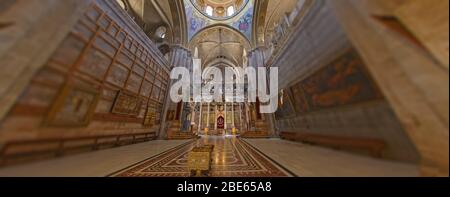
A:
[281,132,386,158]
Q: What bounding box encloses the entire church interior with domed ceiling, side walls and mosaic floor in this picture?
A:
[0,0,449,177]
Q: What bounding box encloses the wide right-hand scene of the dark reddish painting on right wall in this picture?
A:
[302,50,380,110]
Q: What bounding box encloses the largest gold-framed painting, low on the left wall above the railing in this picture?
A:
[44,83,100,127]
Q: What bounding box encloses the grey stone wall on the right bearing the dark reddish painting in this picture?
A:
[273,1,419,163]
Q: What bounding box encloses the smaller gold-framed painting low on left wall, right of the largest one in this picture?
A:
[112,91,142,116]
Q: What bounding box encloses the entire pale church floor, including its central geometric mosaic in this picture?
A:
[0,137,420,177]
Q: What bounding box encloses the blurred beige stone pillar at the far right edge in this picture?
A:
[327,0,449,176]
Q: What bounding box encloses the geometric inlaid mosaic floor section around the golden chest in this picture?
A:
[112,137,292,177]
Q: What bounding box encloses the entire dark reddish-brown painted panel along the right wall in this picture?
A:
[277,49,382,119]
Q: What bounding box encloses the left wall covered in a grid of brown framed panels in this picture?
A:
[0,0,169,144]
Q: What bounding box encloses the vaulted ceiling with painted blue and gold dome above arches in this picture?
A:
[117,0,306,67]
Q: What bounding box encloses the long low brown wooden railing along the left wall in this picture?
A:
[0,132,157,166]
